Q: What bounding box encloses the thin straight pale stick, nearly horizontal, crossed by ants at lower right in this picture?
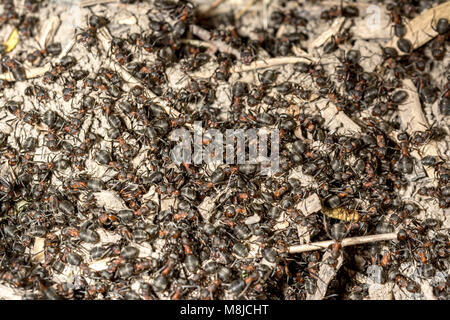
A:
[288,232,397,253]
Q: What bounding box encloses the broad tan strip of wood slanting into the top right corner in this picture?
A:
[386,1,450,55]
